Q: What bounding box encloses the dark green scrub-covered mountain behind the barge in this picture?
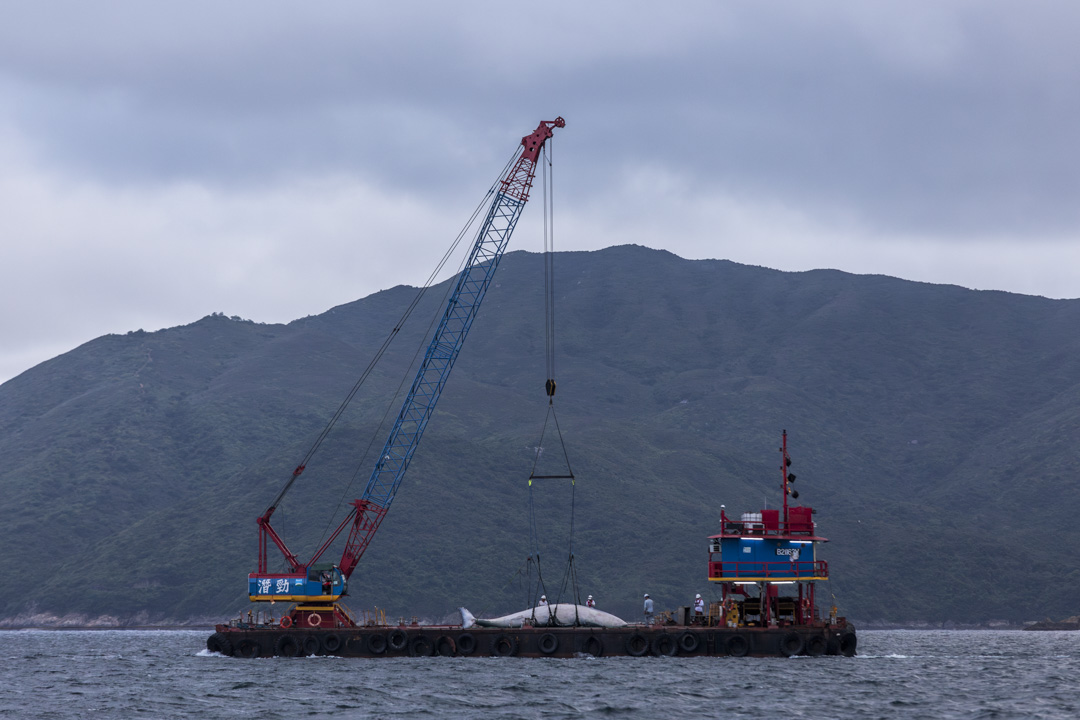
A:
[0,246,1080,623]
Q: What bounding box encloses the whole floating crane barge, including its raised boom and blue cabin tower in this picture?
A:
[206,118,856,657]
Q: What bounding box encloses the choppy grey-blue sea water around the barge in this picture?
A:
[0,630,1080,720]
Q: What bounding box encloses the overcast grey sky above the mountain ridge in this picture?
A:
[0,0,1080,381]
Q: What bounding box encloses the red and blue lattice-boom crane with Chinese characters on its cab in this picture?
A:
[247,118,566,627]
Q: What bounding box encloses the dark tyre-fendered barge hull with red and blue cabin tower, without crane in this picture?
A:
[206,432,859,657]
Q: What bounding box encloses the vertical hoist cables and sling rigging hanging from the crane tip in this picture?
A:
[528,144,581,625]
